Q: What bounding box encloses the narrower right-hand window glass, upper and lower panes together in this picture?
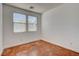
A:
[28,16,37,31]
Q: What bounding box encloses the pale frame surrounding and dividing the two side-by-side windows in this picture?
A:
[12,11,38,33]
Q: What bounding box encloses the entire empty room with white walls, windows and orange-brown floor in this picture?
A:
[0,3,79,56]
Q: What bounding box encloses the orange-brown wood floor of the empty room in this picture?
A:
[2,40,79,56]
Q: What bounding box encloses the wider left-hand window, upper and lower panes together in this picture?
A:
[13,13,26,32]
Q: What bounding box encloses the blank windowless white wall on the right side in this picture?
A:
[42,4,79,52]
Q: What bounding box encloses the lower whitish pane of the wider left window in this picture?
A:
[14,23,26,32]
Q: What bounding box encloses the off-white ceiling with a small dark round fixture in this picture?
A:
[8,3,61,13]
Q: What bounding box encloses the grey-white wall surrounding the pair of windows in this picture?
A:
[3,5,41,48]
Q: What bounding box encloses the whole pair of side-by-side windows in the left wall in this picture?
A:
[13,13,37,32]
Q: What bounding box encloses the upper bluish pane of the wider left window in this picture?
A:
[13,13,26,23]
